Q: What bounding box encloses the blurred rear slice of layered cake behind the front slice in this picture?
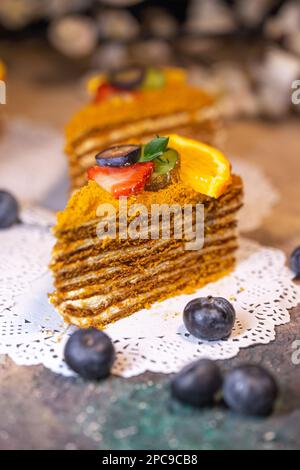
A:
[66,67,219,189]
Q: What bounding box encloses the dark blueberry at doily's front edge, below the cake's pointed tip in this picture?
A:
[65,328,115,380]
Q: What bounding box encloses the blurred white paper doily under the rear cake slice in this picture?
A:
[0,118,278,232]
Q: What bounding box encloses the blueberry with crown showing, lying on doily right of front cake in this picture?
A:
[183,296,235,341]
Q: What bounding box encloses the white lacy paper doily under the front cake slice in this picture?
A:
[0,210,300,377]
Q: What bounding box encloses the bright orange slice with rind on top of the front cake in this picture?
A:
[169,134,231,198]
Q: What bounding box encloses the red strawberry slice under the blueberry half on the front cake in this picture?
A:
[88,162,154,199]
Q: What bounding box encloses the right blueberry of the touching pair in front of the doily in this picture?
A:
[223,364,278,416]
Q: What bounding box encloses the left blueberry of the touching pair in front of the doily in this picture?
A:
[171,359,222,407]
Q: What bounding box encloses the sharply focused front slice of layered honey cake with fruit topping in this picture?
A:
[50,135,243,328]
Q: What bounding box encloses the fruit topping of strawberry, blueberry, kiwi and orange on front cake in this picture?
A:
[88,135,231,198]
